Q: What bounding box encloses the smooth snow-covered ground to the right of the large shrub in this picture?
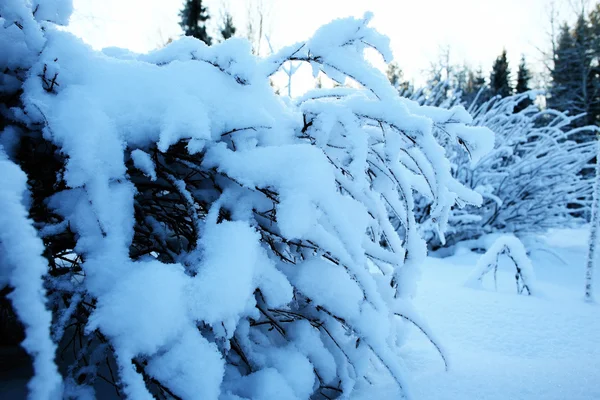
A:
[356,229,600,400]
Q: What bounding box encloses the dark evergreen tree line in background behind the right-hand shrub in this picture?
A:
[387,4,600,130]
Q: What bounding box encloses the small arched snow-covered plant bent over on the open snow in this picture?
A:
[466,235,538,295]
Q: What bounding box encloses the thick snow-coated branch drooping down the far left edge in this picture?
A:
[0,152,62,399]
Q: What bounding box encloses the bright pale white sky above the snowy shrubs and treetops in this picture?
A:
[69,0,573,92]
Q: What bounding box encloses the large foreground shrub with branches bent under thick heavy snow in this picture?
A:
[0,0,493,399]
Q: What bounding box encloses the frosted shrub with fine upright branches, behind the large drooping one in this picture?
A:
[417,92,598,247]
